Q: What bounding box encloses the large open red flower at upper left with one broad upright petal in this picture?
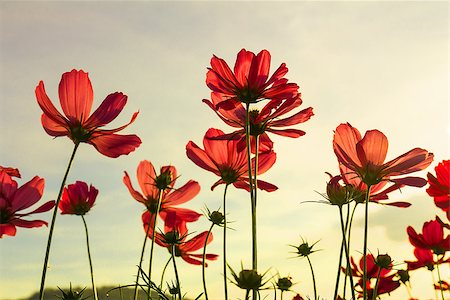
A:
[35,70,141,157]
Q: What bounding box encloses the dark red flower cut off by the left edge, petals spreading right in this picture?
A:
[0,171,55,238]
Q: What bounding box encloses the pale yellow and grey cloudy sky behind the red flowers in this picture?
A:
[0,1,450,299]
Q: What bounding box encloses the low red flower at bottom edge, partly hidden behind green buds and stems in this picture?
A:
[342,254,400,299]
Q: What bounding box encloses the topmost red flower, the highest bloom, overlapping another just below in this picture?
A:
[206,49,298,109]
